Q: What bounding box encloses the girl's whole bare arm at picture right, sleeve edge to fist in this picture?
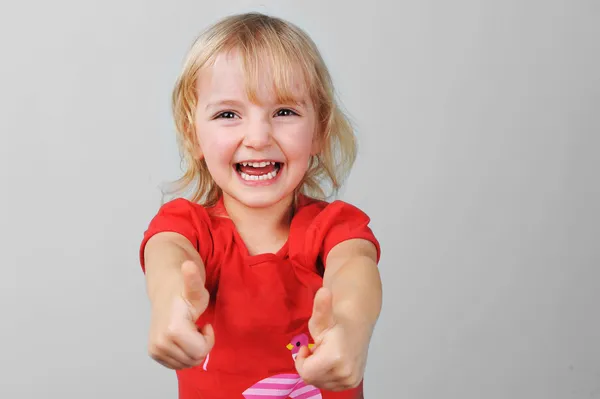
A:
[296,239,382,391]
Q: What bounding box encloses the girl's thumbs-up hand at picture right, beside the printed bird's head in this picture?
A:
[296,287,370,391]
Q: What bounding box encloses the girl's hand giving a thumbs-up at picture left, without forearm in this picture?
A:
[149,261,215,369]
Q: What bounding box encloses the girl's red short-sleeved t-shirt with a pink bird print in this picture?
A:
[140,196,380,399]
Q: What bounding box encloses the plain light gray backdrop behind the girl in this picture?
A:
[0,0,600,399]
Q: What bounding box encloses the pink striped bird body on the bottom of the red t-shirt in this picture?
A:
[243,374,321,399]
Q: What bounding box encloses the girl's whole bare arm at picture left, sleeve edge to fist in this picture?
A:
[144,232,215,369]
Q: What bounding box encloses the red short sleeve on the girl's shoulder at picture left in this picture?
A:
[139,198,213,272]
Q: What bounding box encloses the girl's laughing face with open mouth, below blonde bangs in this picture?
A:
[195,52,317,208]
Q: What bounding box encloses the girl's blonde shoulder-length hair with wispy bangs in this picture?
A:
[164,13,357,206]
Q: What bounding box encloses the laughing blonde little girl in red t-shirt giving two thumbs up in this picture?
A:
[140,13,381,399]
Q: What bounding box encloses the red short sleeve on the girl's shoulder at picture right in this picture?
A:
[316,200,381,262]
